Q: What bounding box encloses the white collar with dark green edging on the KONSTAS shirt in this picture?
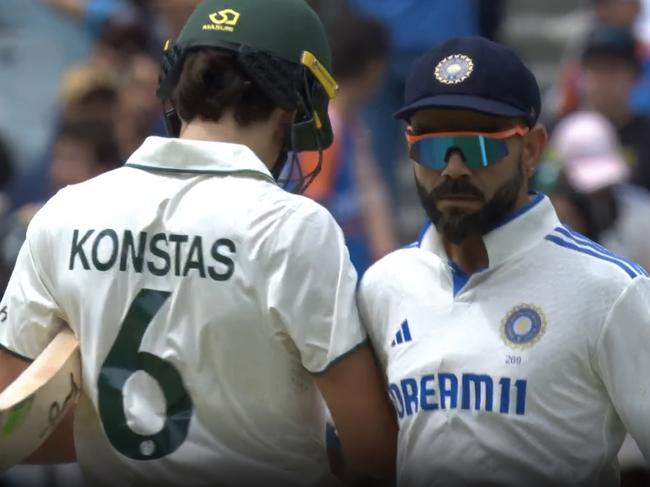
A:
[125,137,275,182]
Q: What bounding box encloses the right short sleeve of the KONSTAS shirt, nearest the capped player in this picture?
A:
[266,199,366,374]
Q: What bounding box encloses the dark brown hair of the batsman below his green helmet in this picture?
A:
[172,48,276,126]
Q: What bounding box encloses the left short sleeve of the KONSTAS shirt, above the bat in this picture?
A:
[0,208,65,360]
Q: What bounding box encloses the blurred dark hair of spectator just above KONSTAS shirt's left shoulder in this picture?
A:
[56,118,122,169]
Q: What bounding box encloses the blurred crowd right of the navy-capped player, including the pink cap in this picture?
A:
[536,0,650,274]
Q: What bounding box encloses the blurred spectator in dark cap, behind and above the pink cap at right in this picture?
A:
[581,26,650,189]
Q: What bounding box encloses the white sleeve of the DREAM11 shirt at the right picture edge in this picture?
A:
[596,277,650,461]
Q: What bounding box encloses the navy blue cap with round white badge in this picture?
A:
[395,37,541,126]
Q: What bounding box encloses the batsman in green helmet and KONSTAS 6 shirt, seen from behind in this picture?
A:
[0,0,397,486]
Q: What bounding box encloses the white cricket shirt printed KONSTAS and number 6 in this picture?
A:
[0,137,365,485]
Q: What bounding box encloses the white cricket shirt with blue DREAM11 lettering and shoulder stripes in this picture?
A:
[359,194,650,487]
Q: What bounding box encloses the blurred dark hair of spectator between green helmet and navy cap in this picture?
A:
[327,14,388,80]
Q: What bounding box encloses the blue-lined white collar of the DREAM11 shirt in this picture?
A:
[418,192,560,268]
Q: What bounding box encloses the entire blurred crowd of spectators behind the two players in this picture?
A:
[0,0,650,485]
